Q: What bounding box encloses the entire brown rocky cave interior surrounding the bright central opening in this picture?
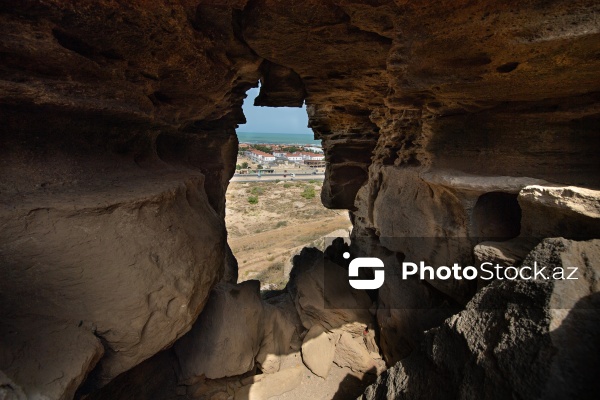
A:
[0,0,600,400]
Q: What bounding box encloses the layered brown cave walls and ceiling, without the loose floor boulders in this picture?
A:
[0,0,600,399]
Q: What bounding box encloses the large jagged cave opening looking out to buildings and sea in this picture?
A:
[225,87,351,292]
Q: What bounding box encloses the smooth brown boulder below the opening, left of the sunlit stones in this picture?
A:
[175,281,265,383]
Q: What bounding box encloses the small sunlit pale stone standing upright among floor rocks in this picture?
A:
[302,325,339,378]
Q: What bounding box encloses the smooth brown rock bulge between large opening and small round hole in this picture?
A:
[356,166,475,303]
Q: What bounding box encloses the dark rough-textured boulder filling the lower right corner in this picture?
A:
[361,239,600,399]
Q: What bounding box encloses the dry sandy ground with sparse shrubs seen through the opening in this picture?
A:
[225,180,351,289]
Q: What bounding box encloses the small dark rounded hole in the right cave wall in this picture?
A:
[472,192,521,241]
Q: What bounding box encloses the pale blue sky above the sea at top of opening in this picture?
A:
[238,88,313,134]
